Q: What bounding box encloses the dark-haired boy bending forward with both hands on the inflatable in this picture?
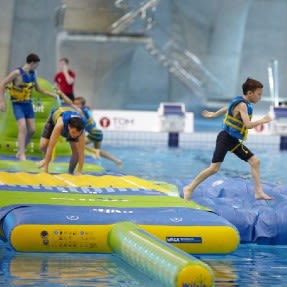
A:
[38,106,86,174]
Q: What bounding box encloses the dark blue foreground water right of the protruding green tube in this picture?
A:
[201,244,287,287]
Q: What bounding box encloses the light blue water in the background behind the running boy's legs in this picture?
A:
[104,146,287,186]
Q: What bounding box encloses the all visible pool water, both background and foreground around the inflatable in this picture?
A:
[0,141,287,287]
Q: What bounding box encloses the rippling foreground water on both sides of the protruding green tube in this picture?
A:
[0,244,287,287]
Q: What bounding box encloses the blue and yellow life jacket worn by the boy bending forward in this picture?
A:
[52,106,86,139]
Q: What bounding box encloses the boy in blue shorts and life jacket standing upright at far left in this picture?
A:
[0,54,57,160]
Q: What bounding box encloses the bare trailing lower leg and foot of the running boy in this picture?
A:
[183,162,221,201]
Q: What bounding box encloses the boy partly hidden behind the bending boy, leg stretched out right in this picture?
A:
[74,97,122,167]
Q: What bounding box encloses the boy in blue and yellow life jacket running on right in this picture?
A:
[183,78,272,200]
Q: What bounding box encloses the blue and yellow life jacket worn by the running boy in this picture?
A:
[223,96,253,140]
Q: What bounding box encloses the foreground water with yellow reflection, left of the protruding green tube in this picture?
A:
[0,245,158,287]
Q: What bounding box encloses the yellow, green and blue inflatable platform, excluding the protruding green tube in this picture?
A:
[0,172,239,254]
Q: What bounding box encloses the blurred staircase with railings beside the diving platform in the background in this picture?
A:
[110,0,223,105]
